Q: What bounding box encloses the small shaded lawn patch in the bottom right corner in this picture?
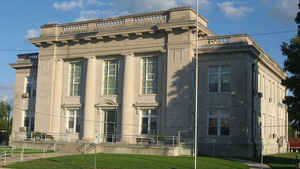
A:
[264,153,300,169]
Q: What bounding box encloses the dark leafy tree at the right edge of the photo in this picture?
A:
[281,2,300,130]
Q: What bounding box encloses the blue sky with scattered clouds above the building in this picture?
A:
[0,0,298,104]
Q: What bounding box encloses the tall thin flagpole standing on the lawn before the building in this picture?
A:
[194,0,199,169]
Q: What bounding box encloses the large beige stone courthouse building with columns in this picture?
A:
[11,7,288,156]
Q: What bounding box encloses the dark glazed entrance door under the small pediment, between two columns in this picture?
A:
[104,110,117,143]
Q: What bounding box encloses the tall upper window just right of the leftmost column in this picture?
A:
[69,61,83,96]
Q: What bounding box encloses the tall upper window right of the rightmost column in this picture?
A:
[141,56,159,95]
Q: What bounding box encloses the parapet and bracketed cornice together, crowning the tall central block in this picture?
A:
[30,7,213,47]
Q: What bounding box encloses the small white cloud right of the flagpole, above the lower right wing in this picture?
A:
[217,1,253,18]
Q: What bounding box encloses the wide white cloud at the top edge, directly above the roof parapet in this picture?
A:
[111,0,209,13]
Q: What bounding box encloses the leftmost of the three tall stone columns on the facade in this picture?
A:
[51,59,63,137]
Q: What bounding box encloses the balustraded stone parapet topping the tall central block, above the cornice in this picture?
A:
[34,6,208,37]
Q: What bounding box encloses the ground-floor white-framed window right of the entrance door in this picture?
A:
[139,108,159,136]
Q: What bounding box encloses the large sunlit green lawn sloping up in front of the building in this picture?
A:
[6,154,248,169]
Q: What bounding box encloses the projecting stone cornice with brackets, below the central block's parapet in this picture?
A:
[30,20,203,47]
